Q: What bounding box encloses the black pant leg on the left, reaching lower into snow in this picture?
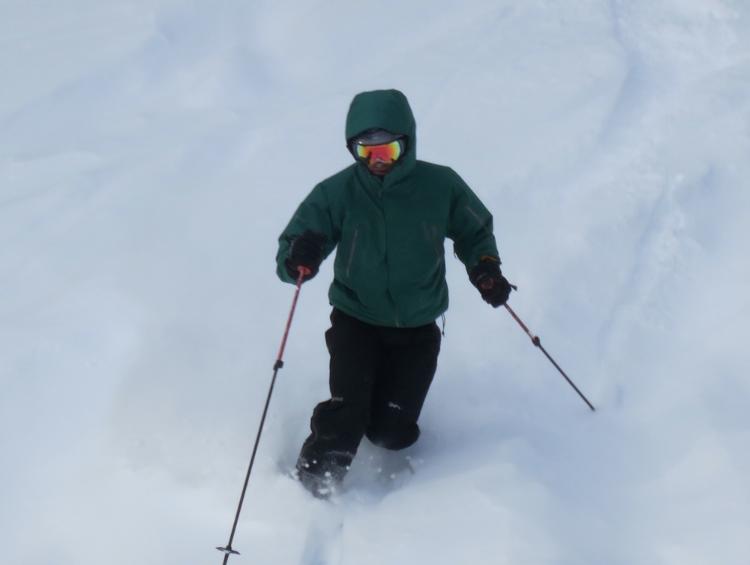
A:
[297,309,380,479]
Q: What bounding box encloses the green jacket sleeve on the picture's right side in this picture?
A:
[448,167,500,272]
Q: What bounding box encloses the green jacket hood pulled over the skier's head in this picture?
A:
[346,89,417,183]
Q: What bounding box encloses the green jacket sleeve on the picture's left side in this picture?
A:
[276,183,339,284]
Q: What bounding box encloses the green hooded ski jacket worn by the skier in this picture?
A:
[276,90,498,327]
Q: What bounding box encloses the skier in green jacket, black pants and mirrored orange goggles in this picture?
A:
[276,86,511,497]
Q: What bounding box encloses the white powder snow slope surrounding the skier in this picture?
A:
[0,0,750,565]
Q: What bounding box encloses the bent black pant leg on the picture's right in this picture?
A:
[366,323,440,449]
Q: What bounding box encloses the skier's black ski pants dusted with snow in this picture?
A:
[297,309,440,479]
